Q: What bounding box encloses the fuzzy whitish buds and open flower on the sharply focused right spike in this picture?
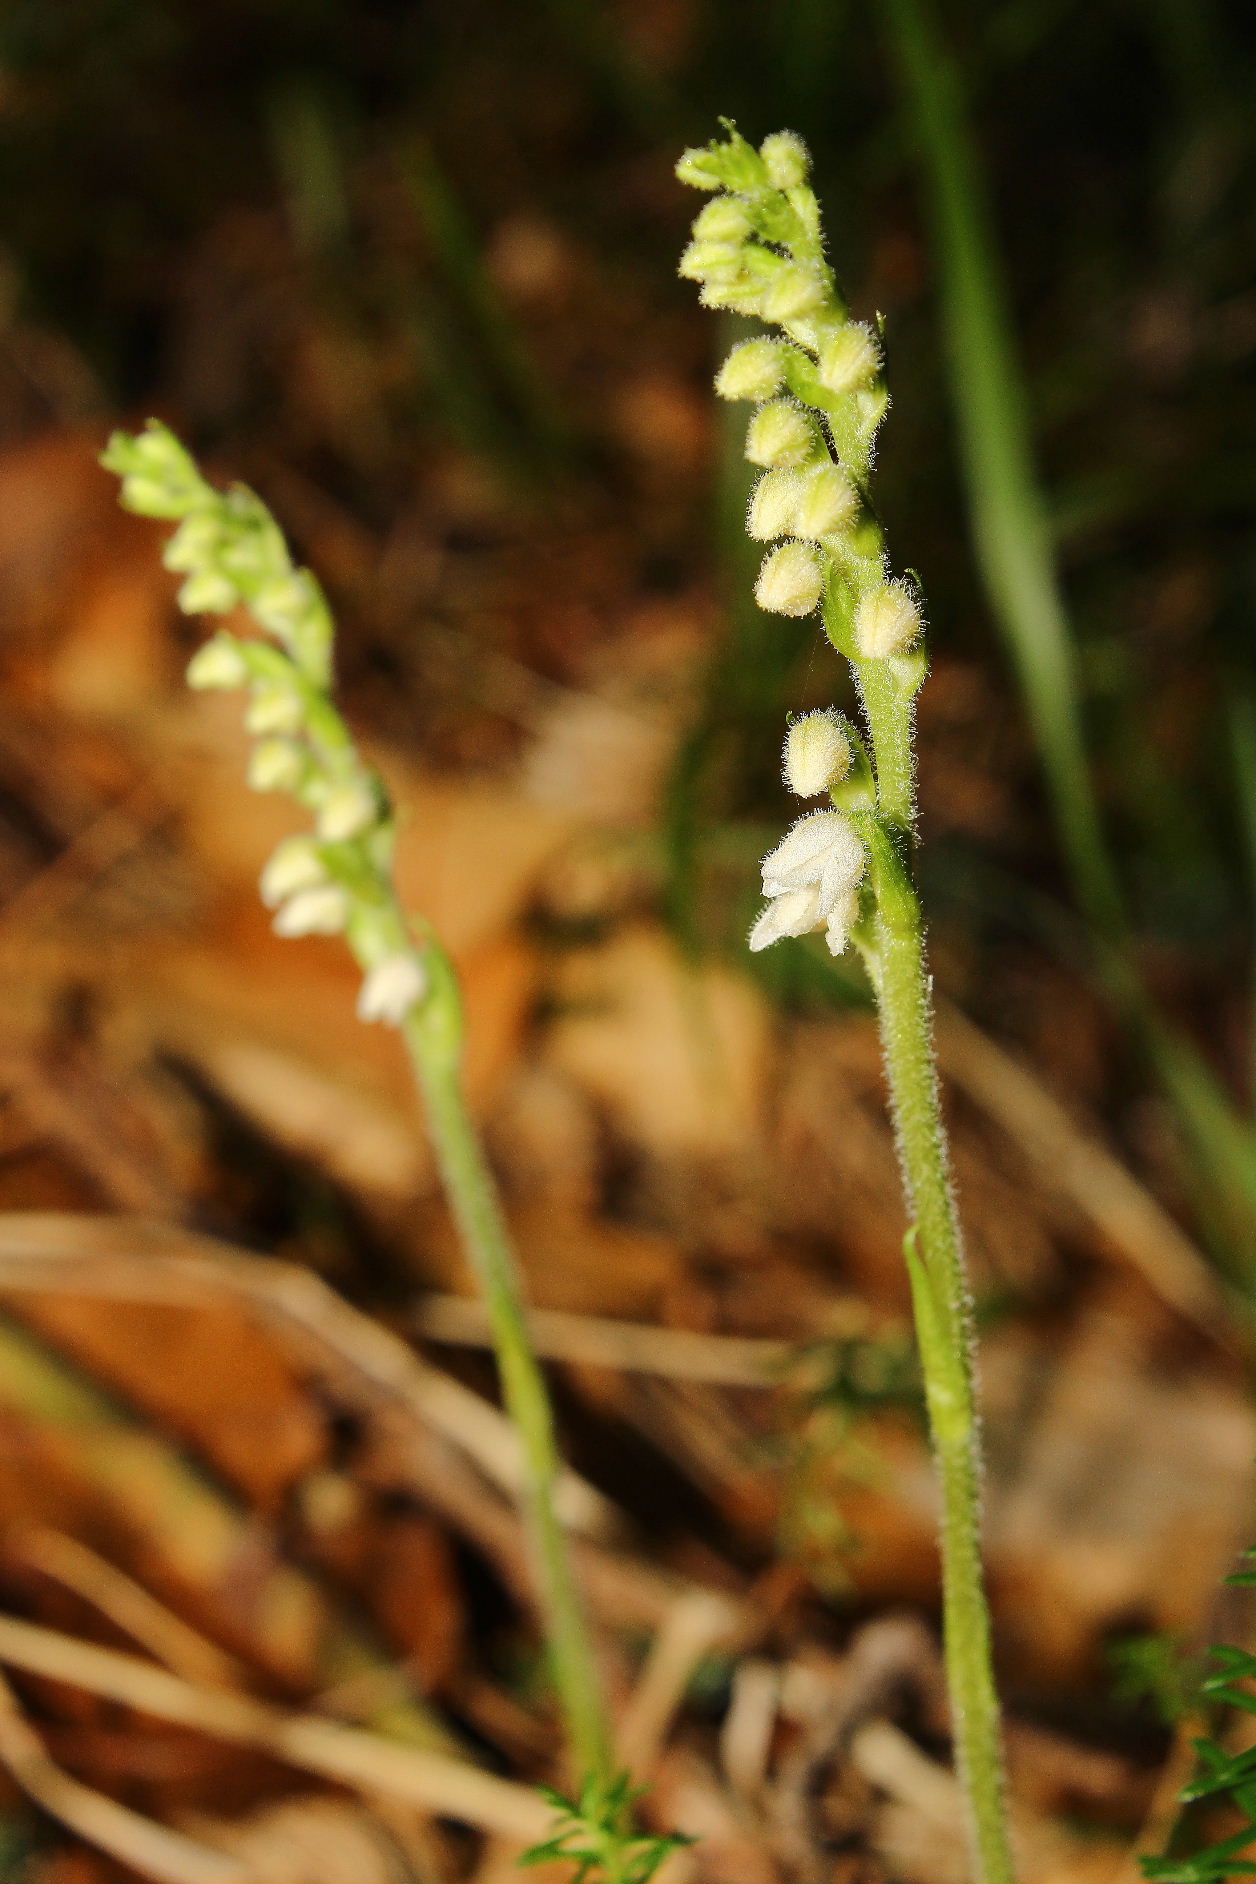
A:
[676,124,925,953]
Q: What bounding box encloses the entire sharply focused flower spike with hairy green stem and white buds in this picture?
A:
[676,124,1013,1884]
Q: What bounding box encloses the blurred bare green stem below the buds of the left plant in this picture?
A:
[403,948,614,1788]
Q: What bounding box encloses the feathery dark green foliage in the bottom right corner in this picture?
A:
[1141,1567,1256,1884]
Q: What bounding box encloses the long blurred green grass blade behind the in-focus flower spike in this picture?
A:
[887,0,1256,1234]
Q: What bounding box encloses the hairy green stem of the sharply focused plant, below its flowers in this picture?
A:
[868,825,1015,1884]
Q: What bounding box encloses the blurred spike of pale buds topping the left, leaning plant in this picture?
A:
[102,420,427,1027]
